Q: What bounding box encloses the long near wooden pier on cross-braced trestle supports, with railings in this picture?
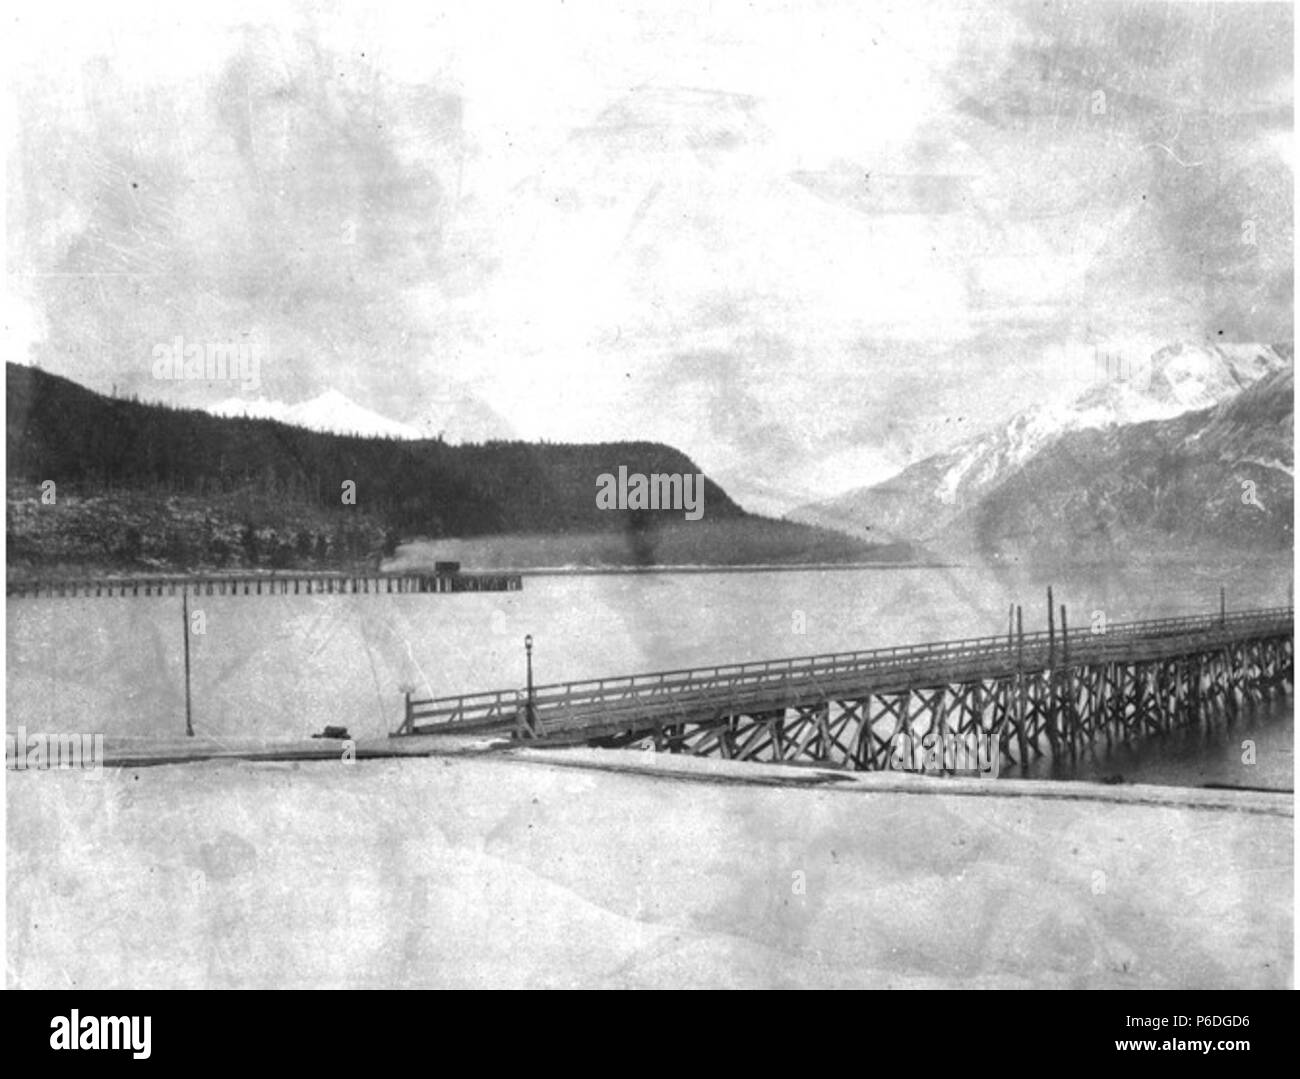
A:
[394,607,1295,770]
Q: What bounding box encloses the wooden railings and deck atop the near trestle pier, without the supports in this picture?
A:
[397,607,1294,735]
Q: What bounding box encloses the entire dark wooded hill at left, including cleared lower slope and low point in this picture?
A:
[5,364,900,568]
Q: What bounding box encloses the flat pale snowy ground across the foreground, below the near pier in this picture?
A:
[7,750,1294,988]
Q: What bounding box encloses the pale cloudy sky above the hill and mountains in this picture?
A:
[4,0,1294,511]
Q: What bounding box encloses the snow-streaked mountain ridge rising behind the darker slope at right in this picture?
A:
[790,343,1291,541]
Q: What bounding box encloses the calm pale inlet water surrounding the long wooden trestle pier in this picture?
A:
[5,568,1292,788]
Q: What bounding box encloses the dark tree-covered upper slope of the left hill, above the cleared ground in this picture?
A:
[5,364,744,536]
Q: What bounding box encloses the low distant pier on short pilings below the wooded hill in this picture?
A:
[5,571,524,599]
